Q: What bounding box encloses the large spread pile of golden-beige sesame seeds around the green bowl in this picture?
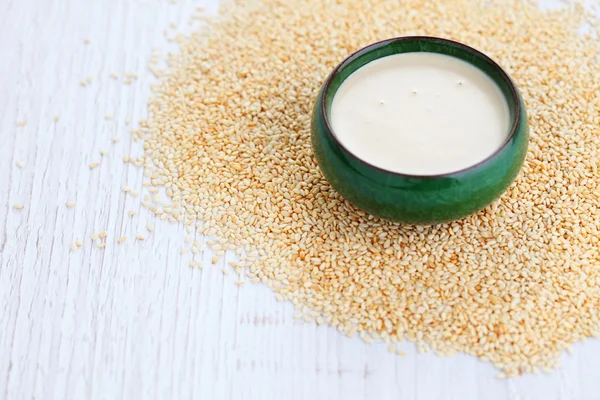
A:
[137,0,600,376]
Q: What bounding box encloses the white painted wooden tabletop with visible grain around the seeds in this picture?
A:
[0,0,600,400]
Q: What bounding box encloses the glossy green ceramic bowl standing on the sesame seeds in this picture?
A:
[312,36,529,225]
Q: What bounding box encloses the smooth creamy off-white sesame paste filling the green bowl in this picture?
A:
[330,52,510,175]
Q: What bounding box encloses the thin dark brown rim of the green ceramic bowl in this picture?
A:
[320,36,523,179]
